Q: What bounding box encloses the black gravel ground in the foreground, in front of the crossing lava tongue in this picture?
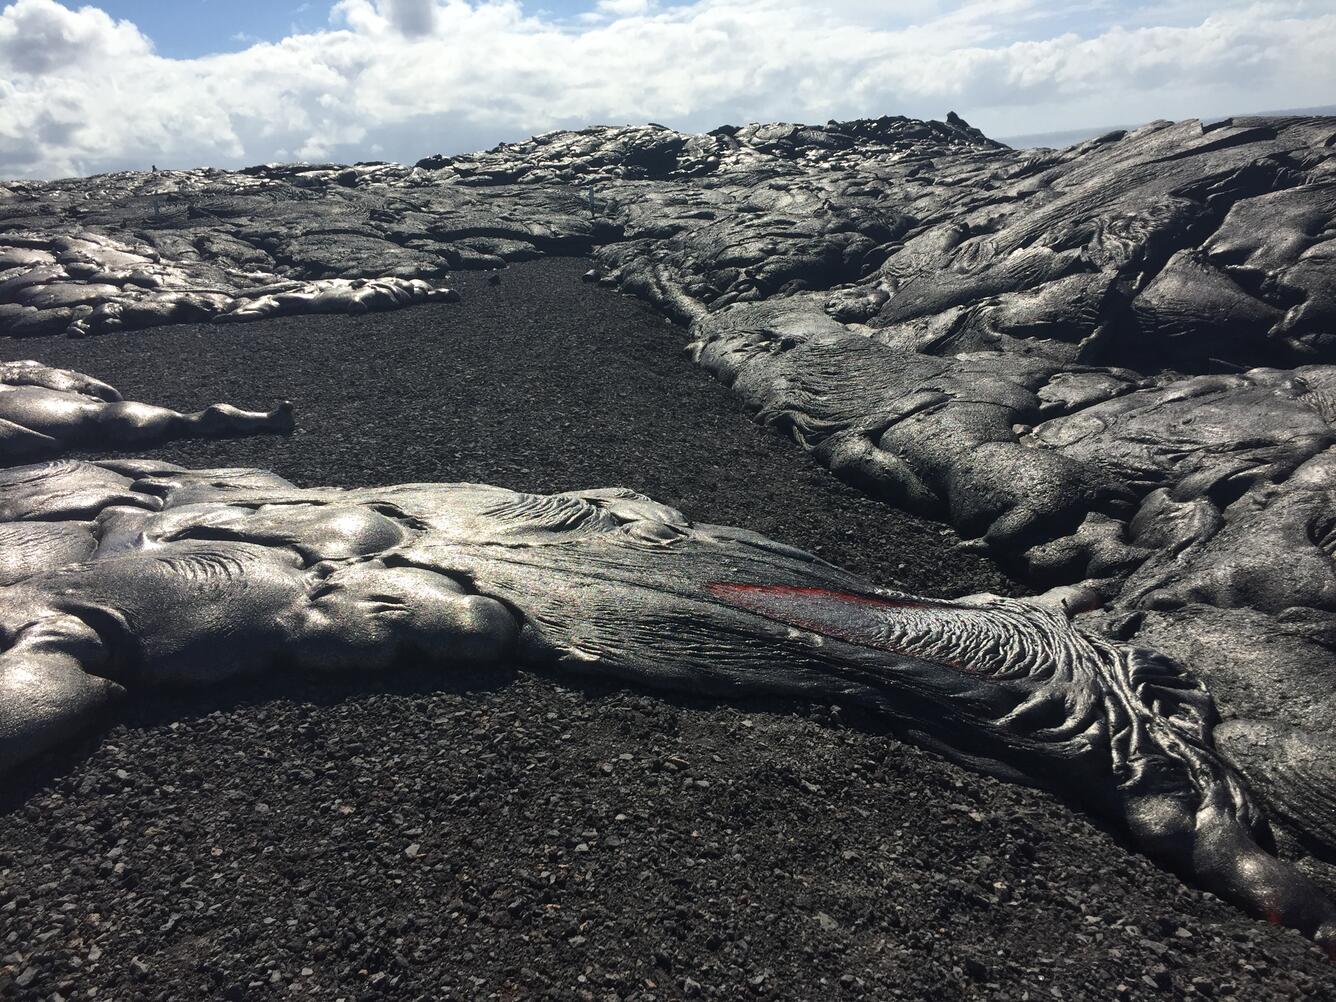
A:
[0,672,1336,1002]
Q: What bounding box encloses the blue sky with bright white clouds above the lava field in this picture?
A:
[0,0,1336,178]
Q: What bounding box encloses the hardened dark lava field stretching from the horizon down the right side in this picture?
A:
[0,118,1336,945]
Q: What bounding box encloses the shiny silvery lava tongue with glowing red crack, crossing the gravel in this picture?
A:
[10,461,1336,950]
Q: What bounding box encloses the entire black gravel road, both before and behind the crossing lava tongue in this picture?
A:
[0,261,1336,1002]
